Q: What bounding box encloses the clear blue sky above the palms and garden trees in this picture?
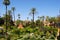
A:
[0,0,60,20]
